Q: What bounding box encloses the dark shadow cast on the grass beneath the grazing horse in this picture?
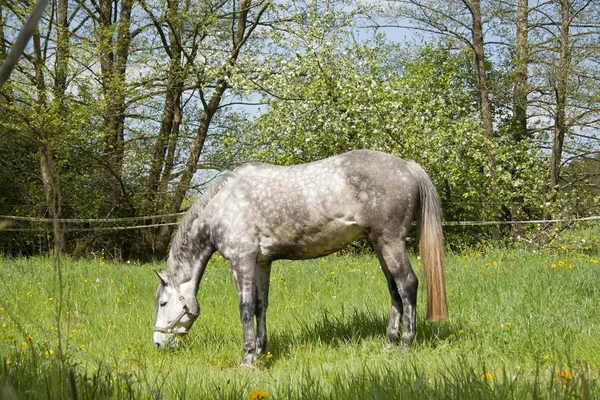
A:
[269,308,459,356]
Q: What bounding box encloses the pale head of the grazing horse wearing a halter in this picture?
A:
[154,271,200,350]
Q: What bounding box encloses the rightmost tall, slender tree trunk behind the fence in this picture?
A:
[548,0,571,200]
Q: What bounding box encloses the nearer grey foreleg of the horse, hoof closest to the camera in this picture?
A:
[231,259,256,366]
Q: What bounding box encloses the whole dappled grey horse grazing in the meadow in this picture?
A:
[154,150,447,365]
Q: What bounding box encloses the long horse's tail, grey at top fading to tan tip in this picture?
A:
[408,162,448,321]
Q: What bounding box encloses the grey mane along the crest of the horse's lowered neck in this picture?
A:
[167,172,233,273]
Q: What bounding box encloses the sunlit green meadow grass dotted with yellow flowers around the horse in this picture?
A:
[0,245,600,399]
